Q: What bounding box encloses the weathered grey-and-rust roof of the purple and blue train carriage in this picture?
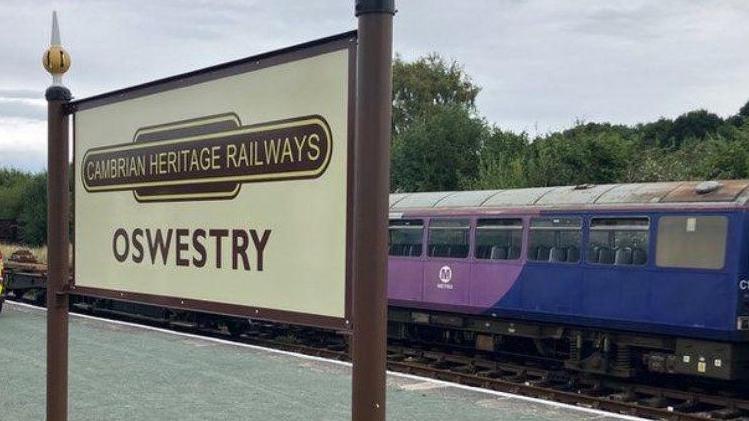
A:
[390,180,749,211]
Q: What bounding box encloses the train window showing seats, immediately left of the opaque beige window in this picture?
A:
[587,218,650,266]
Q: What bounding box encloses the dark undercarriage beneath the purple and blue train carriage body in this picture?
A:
[388,307,749,380]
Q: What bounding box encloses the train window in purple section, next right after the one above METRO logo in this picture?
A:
[475,218,523,260]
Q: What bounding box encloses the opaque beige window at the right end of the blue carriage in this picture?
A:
[655,215,728,269]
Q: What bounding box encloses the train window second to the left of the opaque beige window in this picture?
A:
[528,217,582,263]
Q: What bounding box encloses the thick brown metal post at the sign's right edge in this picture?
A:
[351,0,395,421]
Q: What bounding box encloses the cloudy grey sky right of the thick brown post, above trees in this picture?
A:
[396,0,749,133]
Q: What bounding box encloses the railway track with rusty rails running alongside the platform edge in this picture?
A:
[9,297,749,421]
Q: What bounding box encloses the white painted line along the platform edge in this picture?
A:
[6,301,647,421]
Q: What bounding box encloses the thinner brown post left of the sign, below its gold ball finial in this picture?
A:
[45,85,71,421]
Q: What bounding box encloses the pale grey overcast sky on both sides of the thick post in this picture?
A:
[0,0,749,171]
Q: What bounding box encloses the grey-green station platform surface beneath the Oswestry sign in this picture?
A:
[0,302,635,421]
